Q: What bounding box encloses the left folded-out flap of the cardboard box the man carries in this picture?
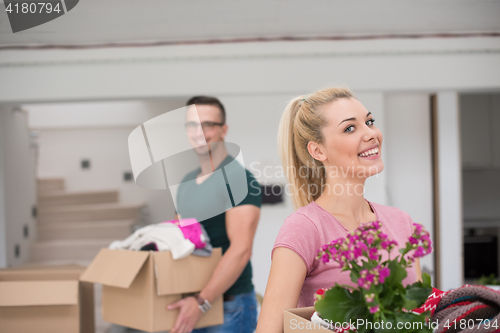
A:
[80,249,149,288]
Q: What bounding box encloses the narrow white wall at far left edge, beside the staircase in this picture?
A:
[0,107,36,266]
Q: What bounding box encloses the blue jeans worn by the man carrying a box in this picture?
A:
[192,291,257,333]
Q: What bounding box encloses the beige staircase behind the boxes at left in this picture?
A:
[30,178,145,333]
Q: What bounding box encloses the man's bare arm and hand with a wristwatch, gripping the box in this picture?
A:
[168,205,260,333]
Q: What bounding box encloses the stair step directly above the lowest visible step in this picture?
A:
[37,220,137,241]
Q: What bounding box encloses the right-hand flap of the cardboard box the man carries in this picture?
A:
[153,247,222,296]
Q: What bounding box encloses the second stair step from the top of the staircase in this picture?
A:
[38,190,118,207]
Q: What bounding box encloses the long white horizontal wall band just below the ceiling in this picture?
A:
[0,37,500,103]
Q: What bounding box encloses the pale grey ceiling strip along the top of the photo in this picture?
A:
[0,0,500,47]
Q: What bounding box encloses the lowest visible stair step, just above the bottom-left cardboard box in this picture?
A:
[30,239,114,262]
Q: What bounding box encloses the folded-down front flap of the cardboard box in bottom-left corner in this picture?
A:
[0,280,78,306]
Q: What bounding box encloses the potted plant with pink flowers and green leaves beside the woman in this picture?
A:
[314,221,432,333]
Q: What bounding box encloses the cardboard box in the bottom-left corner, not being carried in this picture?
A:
[0,265,95,333]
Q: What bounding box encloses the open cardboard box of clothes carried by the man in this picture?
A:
[80,248,224,332]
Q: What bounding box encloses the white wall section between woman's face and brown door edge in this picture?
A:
[384,93,434,283]
